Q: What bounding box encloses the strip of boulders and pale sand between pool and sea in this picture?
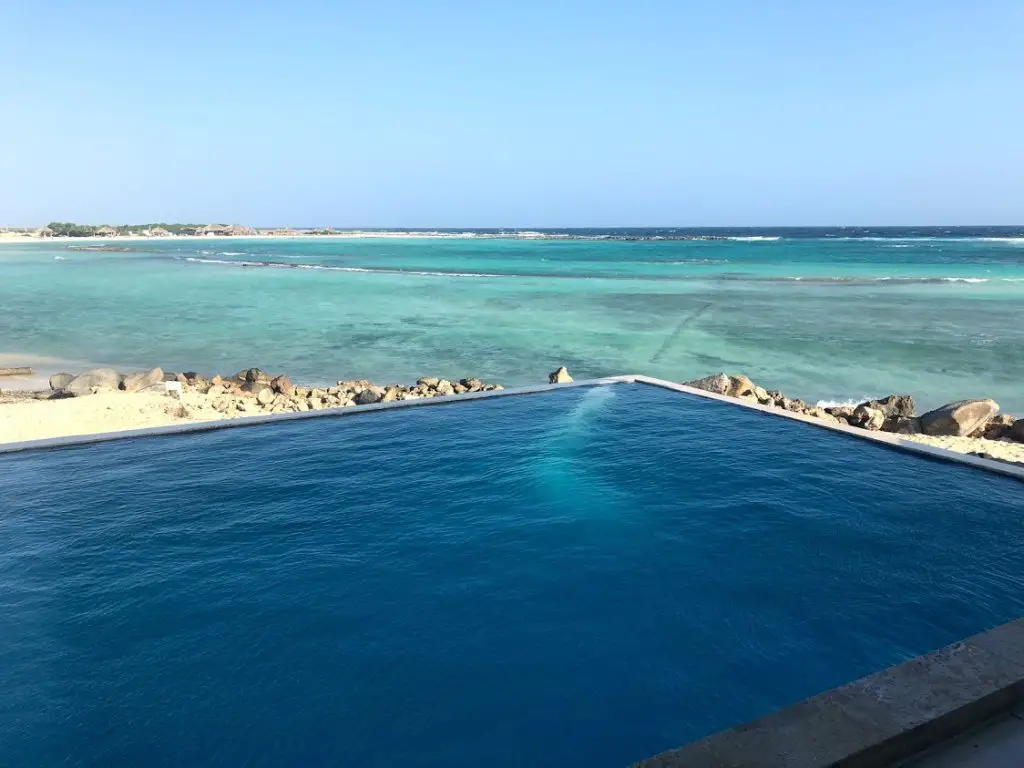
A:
[0,368,1024,463]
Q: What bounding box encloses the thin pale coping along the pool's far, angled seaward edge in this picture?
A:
[0,374,1024,481]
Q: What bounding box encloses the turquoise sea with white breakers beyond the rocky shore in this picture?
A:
[0,227,1024,415]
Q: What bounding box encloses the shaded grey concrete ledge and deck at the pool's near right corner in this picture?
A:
[637,618,1024,768]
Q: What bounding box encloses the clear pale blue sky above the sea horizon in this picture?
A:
[0,0,1024,226]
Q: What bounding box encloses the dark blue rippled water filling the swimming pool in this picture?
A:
[0,385,1024,766]
